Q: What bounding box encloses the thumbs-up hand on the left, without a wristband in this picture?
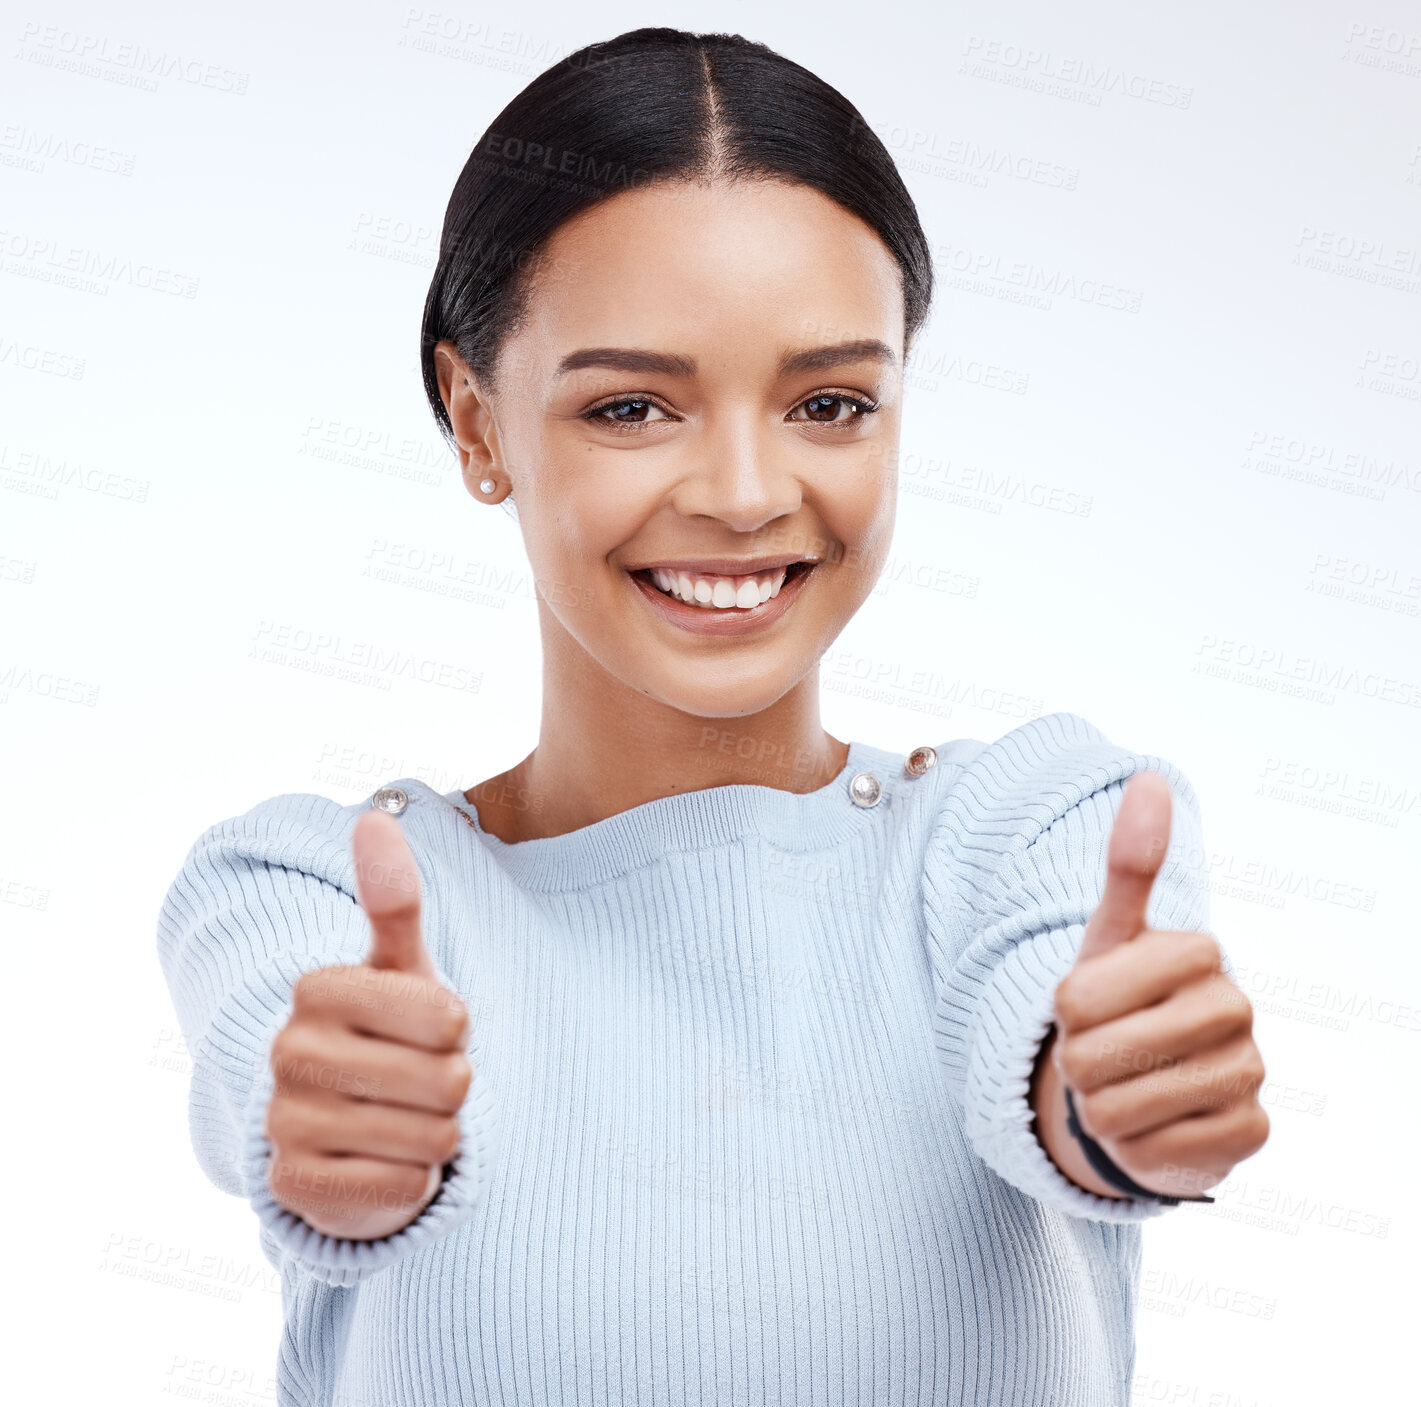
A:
[266,810,473,1241]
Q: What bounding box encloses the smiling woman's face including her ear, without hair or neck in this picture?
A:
[436,182,905,718]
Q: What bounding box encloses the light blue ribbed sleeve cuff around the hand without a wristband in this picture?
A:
[242,969,499,1286]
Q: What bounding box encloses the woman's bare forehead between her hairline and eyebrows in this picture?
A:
[526,180,902,361]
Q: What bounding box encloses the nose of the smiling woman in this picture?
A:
[672,422,804,533]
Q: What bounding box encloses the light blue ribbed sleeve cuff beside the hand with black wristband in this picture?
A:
[963,924,1169,1222]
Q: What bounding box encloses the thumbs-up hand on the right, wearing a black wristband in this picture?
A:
[1043,772,1269,1197]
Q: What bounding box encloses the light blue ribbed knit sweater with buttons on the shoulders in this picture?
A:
[158,712,1208,1407]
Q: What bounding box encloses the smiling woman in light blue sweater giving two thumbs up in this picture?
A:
[159,28,1268,1407]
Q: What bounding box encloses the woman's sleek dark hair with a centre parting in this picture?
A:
[419,27,932,442]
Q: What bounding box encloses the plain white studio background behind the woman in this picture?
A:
[0,0,1421,1407]
